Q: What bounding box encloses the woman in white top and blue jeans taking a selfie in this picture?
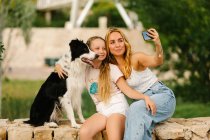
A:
[105,28,176,140]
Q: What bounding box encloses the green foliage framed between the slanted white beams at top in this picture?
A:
[83,0,126,27]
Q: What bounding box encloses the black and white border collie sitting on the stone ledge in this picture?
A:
[25,39,98,128]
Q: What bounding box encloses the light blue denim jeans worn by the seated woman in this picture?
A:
[124,82,176,140]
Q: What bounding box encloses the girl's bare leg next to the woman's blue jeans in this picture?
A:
[106,113,125,140]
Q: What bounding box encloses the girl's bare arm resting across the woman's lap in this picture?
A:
[116,77,156,115]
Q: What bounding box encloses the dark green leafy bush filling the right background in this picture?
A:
[128,0,210,102]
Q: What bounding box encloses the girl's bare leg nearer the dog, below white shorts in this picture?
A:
[79,113,107,140]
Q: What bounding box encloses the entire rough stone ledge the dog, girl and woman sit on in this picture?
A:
[0,117,210,140]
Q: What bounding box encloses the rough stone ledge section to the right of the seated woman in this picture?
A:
[155,117,210,140]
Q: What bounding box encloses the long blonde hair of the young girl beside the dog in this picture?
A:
[86,36,111,102]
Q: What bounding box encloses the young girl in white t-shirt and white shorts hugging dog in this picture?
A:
[54,36,155,140]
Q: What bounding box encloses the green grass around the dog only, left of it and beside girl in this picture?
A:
[1,80,95,120]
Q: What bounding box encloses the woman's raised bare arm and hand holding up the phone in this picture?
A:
[134,28,163,67]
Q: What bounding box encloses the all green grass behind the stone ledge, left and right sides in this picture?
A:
[1,80,210,120]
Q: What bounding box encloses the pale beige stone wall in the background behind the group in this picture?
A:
[2,28,153,80]
